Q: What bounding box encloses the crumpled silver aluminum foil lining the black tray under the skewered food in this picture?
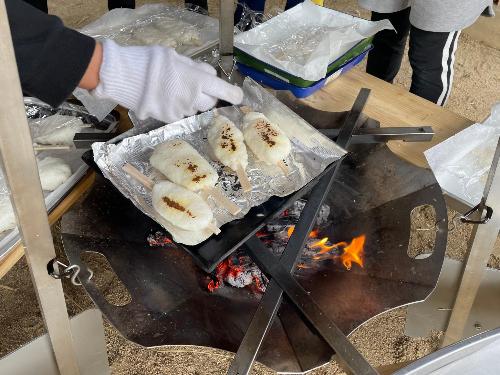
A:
[92,78,345,245]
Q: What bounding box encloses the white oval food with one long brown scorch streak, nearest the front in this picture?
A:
[152,181,213,231]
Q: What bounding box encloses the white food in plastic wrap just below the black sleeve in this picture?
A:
[30,114,84,146]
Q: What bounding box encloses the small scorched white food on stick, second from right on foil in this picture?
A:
[208,116,248,172]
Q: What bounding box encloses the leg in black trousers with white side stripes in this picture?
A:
[408,26,460,105]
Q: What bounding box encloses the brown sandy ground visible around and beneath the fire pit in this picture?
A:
[0,0,500,375]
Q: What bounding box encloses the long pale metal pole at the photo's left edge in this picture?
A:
[0,0,80,375]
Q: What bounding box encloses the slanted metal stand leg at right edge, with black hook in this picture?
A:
[442,141,500,346]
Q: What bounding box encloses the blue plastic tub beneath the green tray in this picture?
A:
[236,48,371,98]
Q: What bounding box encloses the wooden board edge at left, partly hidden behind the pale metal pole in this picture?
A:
[0,171,95,279]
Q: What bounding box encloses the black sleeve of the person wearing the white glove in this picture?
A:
[6,0,95,106]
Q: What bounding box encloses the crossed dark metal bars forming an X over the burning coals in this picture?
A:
[228,89,376,375]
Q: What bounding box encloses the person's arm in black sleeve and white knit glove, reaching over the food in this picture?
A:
[6,0,243,122]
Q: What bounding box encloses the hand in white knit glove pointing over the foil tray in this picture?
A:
[91,40,243,122]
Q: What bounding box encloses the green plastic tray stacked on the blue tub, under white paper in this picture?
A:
[234,36,373,87]
